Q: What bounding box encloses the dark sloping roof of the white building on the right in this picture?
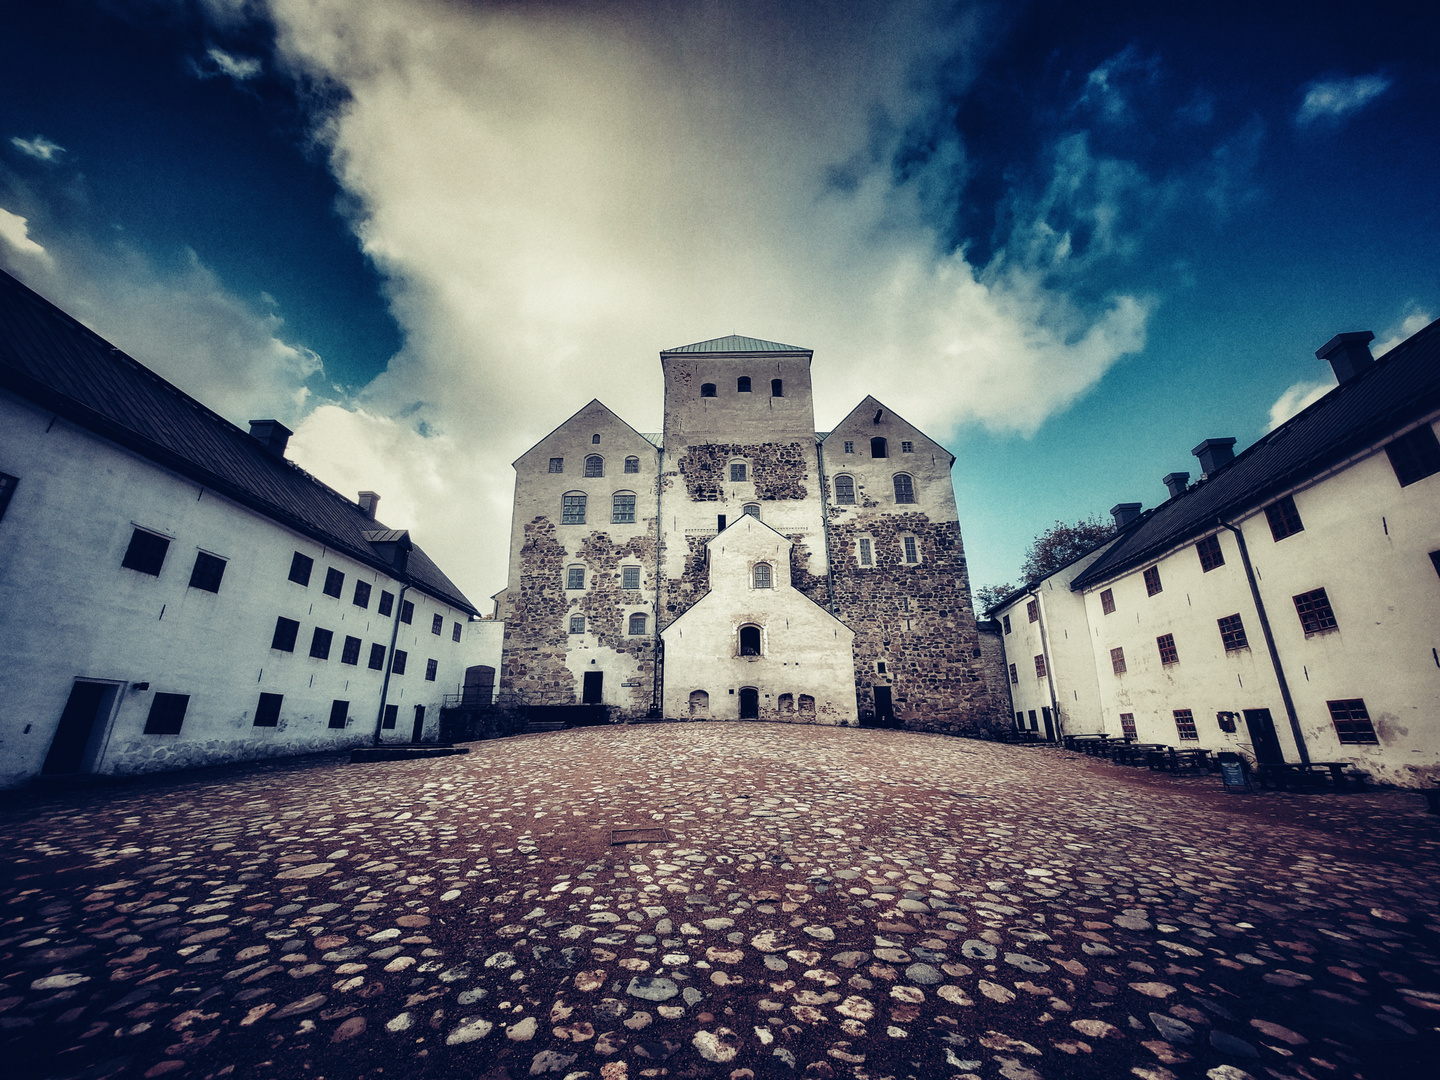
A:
[1071,320,1440,589]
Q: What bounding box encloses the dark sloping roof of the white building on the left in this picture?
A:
[0,271,478,615]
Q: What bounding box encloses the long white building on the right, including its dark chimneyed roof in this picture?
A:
[994,323,1440,786]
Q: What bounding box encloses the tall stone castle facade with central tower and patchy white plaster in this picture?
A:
[497,336,1008,732]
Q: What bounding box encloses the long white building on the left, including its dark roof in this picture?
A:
[0,266,484,786]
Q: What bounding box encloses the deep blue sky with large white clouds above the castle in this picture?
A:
[0,0,1440,602]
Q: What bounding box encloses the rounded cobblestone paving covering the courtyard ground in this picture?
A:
[0,724,1440,1080]
